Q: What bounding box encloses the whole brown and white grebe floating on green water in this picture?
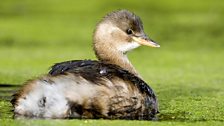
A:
[11,9,160,120]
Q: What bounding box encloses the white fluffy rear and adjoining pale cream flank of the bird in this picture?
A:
[15,75,96,118]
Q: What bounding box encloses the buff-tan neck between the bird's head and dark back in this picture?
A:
[94,47,140,77]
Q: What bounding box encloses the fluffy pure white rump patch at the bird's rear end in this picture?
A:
[15,80,68,118]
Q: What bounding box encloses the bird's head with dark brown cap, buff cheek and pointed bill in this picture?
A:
[94,10,160,53]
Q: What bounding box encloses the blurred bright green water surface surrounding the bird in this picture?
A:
[0,0,224,125]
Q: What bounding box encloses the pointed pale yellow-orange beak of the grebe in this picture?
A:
[132,35,160,47]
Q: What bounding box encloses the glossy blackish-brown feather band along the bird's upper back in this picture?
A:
[49,60,156,99]
